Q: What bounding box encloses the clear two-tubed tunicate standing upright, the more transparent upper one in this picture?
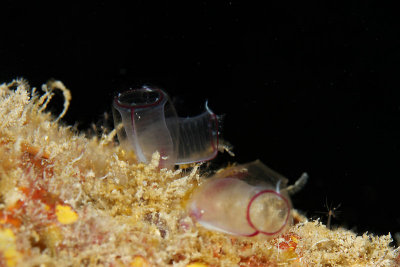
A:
[113,87,218,168]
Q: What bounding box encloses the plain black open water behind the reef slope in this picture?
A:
[0,0,400,239]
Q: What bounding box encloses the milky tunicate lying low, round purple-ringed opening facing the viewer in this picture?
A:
[188,161,292,237]
